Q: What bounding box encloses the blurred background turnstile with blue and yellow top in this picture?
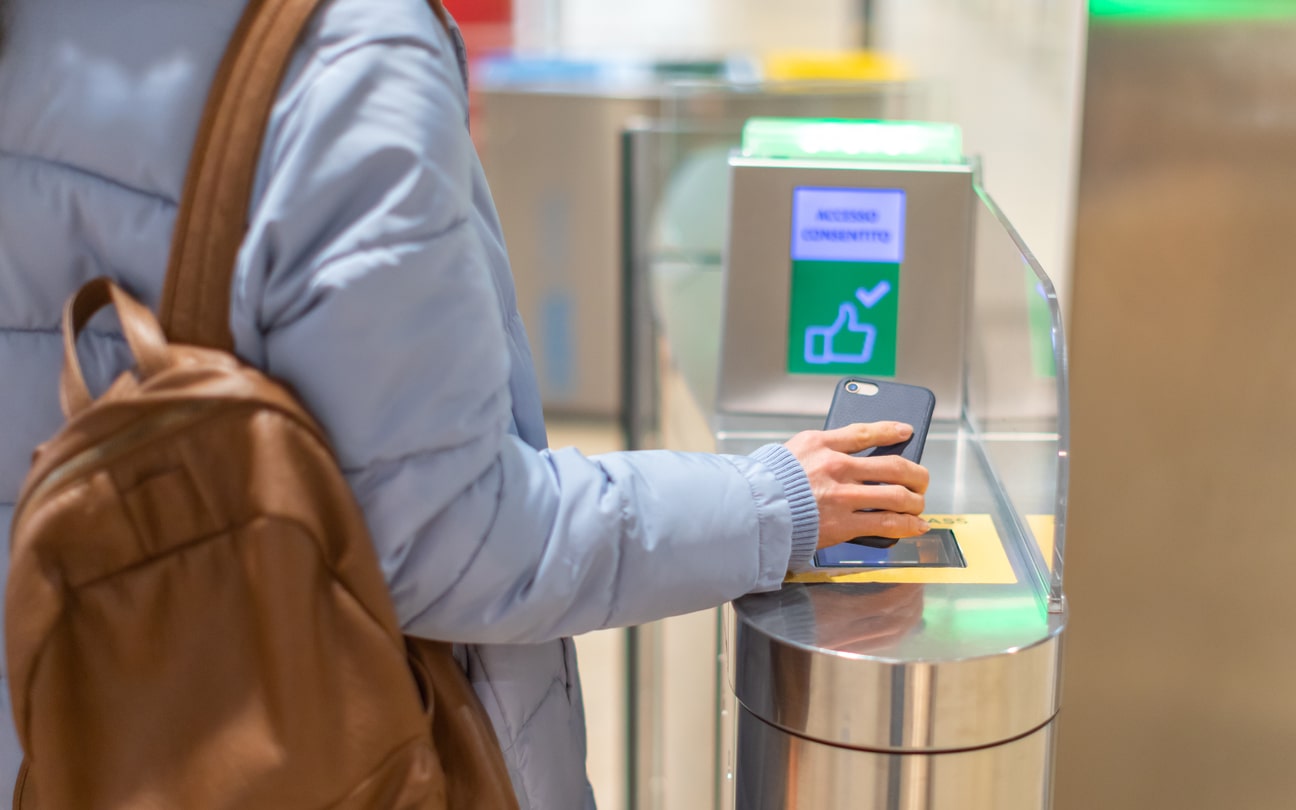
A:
[476,64,917,417]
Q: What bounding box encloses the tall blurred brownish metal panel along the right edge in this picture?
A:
[1056,12,1296,810]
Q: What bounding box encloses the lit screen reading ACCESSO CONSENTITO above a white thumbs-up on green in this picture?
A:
[788,188,905,377]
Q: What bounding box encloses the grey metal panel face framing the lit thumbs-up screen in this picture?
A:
[718,157,975,419]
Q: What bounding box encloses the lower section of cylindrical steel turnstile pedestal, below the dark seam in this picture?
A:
[730,709,1054,810]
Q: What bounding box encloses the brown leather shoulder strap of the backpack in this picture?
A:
[159,0,329,351]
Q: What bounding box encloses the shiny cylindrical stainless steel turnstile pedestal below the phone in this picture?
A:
[727,583,1061,810]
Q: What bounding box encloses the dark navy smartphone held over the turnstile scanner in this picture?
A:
[823,377,936,548]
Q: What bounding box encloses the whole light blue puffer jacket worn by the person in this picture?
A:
[0,0,818,810]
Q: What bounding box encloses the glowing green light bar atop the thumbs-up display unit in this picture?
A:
[743,118,964,163]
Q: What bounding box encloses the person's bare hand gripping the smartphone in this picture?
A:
[784,422,929,548]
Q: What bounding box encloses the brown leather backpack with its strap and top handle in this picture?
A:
[5,0,517,810]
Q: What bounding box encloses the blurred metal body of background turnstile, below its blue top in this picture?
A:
[478,88,661,416]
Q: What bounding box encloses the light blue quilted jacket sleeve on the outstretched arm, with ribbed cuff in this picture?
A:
[232,3,818,643]
